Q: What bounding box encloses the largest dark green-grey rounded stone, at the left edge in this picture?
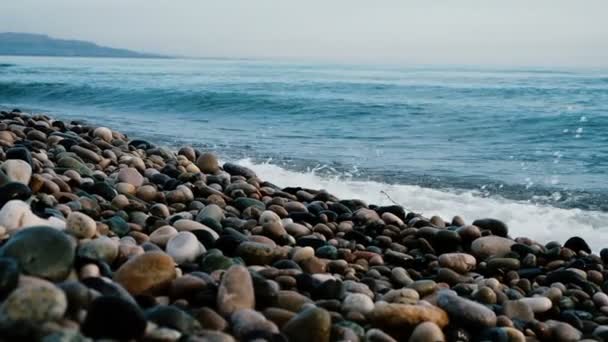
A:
[0,226,76,281]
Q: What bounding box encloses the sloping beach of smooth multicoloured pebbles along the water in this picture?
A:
[0,110,608,342]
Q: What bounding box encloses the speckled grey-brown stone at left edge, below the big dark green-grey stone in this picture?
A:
[0,283,68,322]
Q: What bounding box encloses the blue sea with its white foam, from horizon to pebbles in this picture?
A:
[0,56,608,251]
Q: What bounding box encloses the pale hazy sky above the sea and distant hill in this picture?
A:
[0,0,608,66]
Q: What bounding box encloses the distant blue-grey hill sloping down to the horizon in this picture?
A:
[0,32,168,58]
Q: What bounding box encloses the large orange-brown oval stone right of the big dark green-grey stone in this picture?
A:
[114,252,176,295]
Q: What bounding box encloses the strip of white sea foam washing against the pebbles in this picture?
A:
[238,159,608,252]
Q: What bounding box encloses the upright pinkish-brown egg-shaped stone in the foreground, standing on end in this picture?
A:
[217,265,255,316]
